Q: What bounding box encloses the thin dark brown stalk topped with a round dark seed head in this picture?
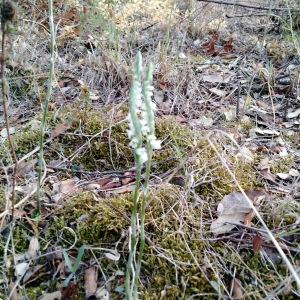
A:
[1,2,18,220]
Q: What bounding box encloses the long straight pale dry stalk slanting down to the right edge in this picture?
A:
[207,137,300,290]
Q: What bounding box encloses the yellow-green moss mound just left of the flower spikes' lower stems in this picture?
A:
[46,192,131,245]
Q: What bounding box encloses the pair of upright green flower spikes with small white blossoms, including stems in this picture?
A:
[125,52,160,299]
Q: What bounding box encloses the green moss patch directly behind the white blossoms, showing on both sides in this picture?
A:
[48,107,193,172]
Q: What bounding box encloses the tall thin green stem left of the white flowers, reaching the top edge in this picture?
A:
[36,0,55,215]
